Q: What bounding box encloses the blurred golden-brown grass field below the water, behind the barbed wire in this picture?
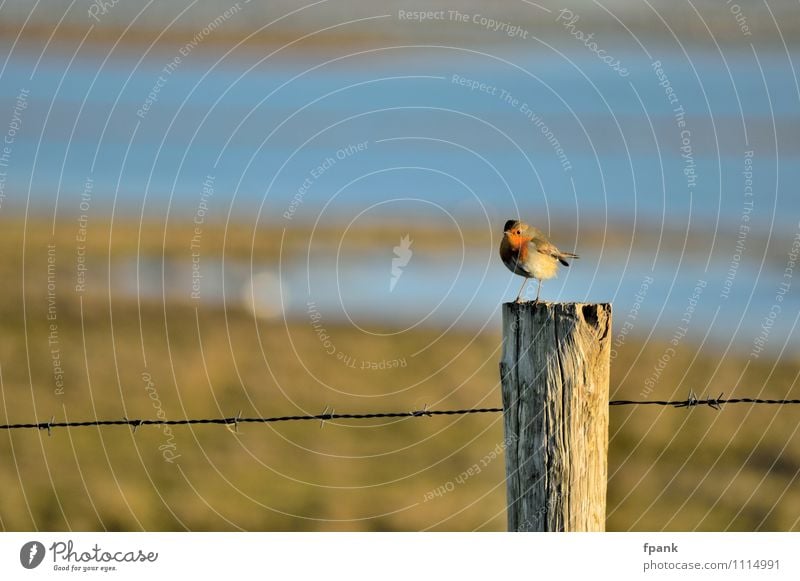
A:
[0,220,800,531]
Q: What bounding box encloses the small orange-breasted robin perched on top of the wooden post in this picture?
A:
[500,220,578,303]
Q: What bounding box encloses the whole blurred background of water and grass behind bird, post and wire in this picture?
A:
[0,0,800,531]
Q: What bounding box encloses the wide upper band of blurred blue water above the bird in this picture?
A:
[0,43,800,227]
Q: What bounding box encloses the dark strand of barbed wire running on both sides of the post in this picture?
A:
[0,393,800,435]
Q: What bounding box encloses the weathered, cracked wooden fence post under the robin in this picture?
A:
[500,302,611,531]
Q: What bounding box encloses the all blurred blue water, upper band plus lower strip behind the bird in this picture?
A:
[0,44,800,347]
